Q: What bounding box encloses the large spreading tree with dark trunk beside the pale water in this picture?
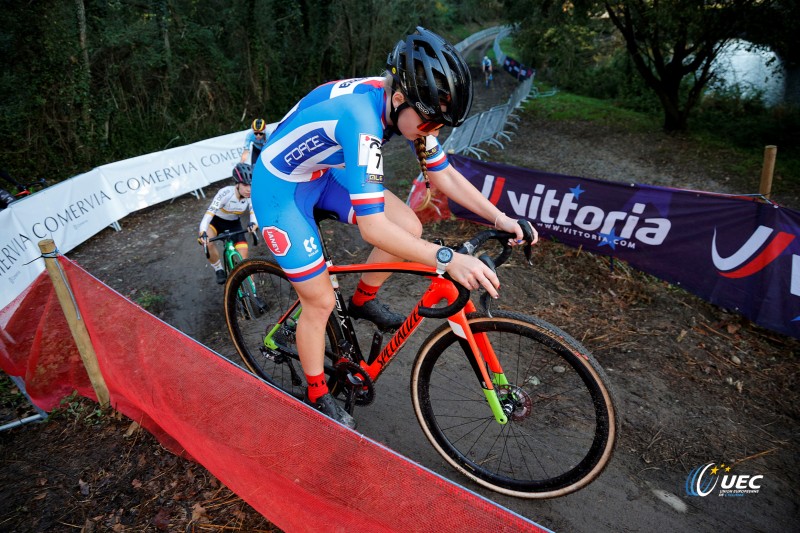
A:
[509,0,776,131]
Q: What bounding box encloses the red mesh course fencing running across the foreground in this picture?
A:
[0,257,543,532]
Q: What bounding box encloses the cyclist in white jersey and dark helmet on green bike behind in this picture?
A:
[197,163,258,285]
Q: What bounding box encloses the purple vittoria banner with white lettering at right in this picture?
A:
[448,155,800,338]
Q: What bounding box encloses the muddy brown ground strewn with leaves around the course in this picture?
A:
[0,64,800,532]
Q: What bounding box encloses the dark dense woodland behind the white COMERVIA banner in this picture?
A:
[0,0,488,183]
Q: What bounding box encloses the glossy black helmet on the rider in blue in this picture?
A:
[386,26,472,127]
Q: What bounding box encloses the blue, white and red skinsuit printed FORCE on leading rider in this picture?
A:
[252,78,449,281]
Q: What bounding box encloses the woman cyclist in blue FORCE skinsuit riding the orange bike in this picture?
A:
[253,27,536,427]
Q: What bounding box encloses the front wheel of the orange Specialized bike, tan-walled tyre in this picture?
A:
[411,311,619,499]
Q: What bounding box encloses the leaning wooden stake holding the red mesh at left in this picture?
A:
[39,239,110,407]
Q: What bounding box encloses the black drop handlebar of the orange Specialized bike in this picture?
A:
[419,220,533,318]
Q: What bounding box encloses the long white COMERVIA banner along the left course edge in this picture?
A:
[0,125,256,309]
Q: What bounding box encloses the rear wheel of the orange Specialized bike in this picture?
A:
[225,259,341,399]
